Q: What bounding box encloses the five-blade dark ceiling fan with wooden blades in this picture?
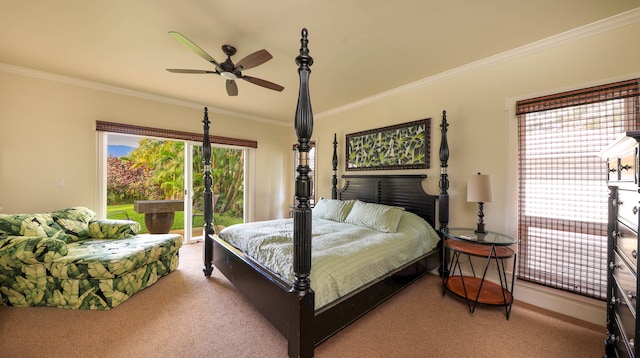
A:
[167,31,284,96]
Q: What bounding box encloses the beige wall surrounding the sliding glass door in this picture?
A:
[0,71,292,220]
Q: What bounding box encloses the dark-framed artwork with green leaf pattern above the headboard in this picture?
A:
[345,118,431,170]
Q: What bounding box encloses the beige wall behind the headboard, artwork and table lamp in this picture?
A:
[312,23,640,325]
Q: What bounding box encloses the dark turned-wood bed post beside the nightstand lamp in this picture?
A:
[438,111,449,277]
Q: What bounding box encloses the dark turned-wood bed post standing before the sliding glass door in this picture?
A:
[202,107,215,277]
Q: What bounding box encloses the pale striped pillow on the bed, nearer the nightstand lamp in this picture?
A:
[344,200,402,232]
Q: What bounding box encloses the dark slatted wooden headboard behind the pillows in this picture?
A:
[338,175,438,229]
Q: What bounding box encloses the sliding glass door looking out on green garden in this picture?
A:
[103,133,247,242]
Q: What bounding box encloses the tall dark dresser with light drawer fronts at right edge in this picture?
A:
[601,131,640,357]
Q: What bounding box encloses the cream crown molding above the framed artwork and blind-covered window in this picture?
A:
[314,7,640,119]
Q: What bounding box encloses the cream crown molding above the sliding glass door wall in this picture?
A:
[0,62,290,127]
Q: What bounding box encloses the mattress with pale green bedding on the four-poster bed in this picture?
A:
[219,211,439,309]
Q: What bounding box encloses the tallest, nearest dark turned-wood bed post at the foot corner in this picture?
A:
[287,29,315,357]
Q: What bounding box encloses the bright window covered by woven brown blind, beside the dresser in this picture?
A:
[516,79,640,300]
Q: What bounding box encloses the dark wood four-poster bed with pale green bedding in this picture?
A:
[203,29,449,357]
